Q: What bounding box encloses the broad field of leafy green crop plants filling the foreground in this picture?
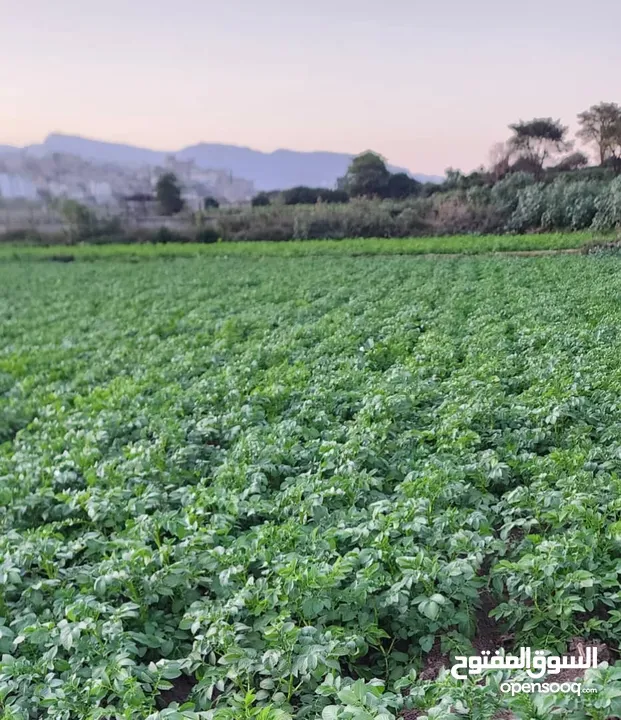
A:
[0,255,621,720]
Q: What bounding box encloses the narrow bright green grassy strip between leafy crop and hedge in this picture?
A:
[0,232,594,261]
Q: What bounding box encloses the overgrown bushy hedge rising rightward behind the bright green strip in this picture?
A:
[0,173,621,243]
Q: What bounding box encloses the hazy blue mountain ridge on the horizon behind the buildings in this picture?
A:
[0,133,443,190]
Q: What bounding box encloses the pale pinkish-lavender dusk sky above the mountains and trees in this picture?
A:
[0,0,621,174]
